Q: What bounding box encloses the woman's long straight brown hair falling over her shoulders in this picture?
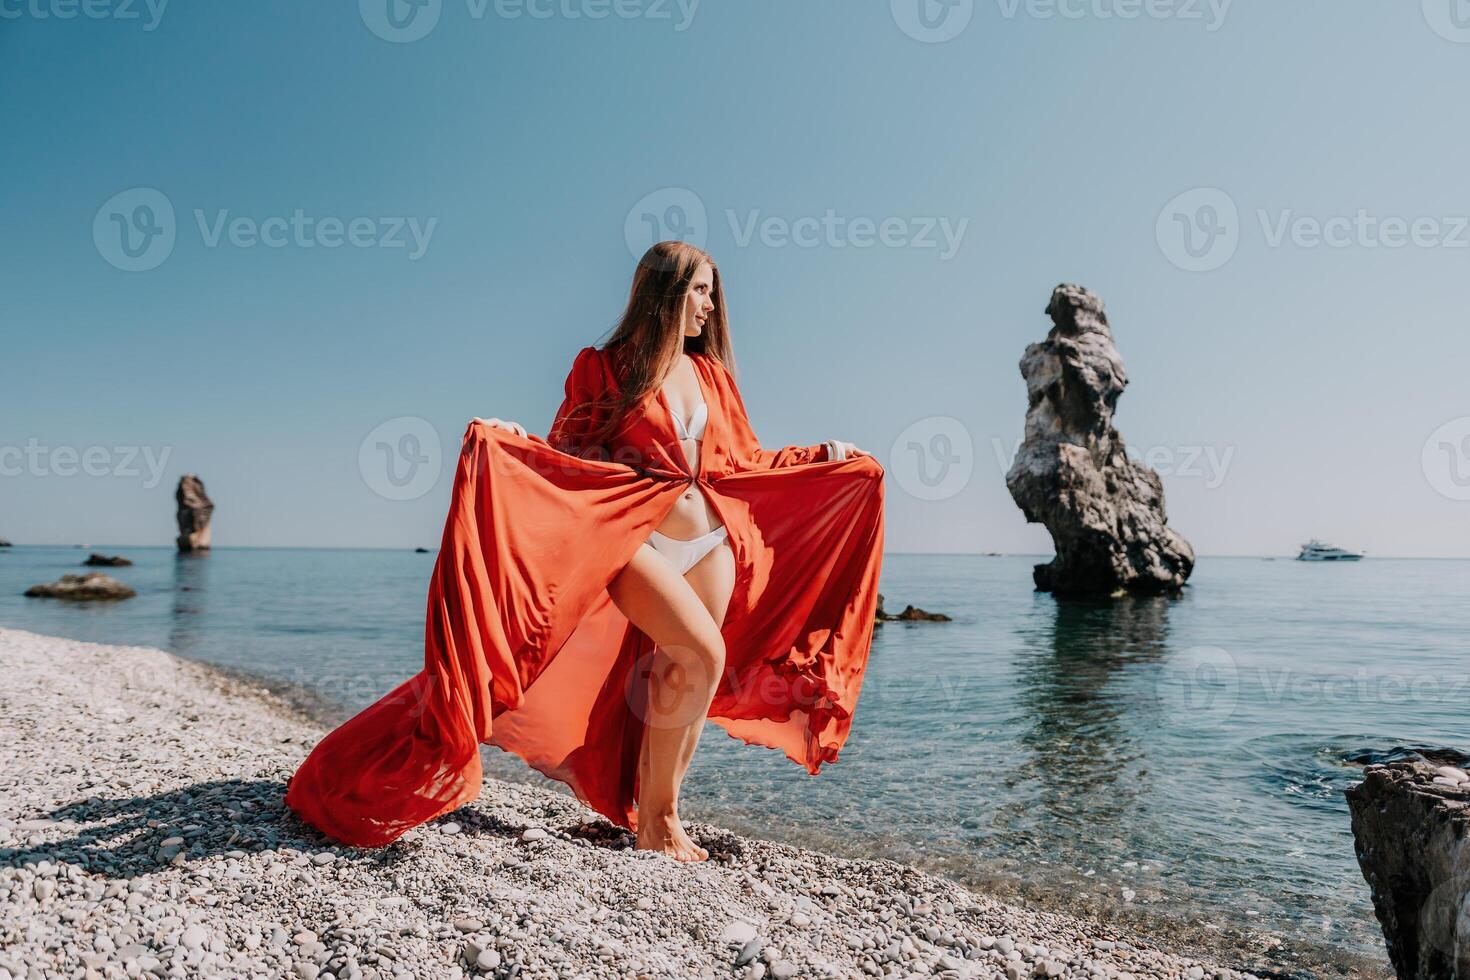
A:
[573,241,735,445]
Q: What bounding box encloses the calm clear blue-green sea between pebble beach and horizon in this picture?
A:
[0,548,1470,976]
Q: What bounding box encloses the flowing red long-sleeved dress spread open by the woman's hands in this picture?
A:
[285,347,883,846]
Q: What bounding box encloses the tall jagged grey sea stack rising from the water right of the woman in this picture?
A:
[1005,285,1194,595]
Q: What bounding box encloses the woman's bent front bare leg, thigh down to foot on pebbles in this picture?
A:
[607,544,725,861]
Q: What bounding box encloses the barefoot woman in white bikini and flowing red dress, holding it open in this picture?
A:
[287,241,882,861]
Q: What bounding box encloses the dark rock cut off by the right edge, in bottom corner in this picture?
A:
[1347,752,1470,980]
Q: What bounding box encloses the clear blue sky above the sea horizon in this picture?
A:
[0,0,1470,555]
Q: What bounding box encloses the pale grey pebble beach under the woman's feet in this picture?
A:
[0,627,1352,980]
